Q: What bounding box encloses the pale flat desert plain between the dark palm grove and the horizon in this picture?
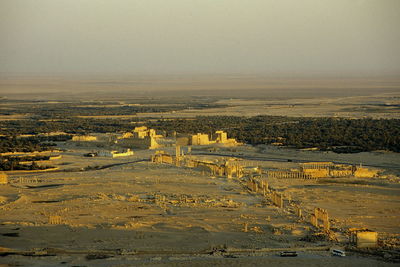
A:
[0,75,400,120]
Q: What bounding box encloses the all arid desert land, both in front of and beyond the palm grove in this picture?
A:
[0,77,400,266]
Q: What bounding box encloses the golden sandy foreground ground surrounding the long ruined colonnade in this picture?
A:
[0,142,400,266]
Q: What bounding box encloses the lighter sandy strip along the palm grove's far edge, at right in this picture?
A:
[135,93,400,119]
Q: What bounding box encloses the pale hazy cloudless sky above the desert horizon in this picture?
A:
[0,0,400,75]
